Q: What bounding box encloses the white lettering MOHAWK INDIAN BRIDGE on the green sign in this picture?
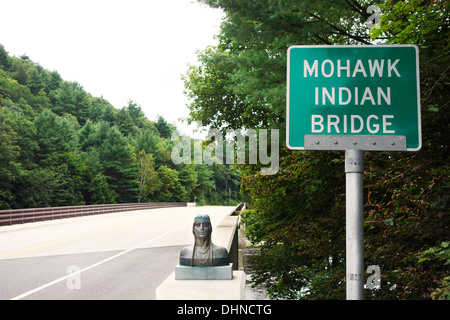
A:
[303,59,401,134]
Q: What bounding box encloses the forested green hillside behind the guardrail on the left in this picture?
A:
[0,45,240,209]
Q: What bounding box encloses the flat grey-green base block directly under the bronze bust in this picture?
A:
[175,263,233,280]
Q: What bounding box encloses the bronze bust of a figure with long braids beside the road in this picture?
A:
[180,215,230,266]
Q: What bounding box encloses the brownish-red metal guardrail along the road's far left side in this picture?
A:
[0,202,187,226]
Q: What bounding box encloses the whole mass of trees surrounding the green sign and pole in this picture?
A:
[184,0,450,299]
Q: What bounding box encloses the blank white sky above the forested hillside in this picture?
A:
[0,0,223,134]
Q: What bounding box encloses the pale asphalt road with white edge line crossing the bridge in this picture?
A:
[0,207,234,300]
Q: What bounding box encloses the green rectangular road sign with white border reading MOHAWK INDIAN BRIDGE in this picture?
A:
[286,45,422,151]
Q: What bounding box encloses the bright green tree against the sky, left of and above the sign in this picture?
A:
[185,0,377,129]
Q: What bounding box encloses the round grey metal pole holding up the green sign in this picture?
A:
[345,149,364,300]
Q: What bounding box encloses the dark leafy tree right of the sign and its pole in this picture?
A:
[366,0,450,299]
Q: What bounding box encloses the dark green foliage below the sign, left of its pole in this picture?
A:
[243,150,345,299]
